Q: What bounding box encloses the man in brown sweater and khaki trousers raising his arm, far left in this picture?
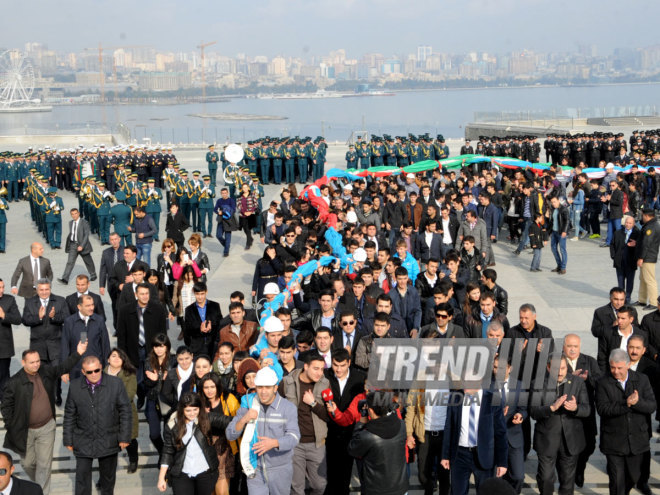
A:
[0,342,87,493]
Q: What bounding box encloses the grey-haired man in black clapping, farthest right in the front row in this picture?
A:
[596,348,655,495]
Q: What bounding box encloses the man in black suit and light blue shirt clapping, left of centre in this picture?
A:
[183,282,222,359]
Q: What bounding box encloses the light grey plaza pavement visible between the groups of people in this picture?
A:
[0,146,660,495]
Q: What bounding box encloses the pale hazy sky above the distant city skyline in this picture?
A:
[5,0,660,57]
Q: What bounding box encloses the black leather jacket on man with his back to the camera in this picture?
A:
[348,412,408,495]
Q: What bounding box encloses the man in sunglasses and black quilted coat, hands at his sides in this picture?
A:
[62,356,133,495]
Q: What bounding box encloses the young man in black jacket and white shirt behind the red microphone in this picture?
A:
[325,348,366,495]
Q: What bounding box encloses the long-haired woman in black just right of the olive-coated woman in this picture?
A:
[144,333,177,454]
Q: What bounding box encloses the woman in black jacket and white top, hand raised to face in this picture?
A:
[158,392,231,495]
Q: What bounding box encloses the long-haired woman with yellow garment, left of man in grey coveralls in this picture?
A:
[199,373,239,495]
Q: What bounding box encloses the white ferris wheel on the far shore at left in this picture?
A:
[0,50,34,108]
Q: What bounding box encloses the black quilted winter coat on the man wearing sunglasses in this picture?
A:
[62,373,133,459]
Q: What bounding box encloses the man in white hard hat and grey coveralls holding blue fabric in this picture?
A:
[225,367,300,495]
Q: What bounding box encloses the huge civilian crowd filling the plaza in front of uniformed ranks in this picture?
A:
[0,131,660,495]
